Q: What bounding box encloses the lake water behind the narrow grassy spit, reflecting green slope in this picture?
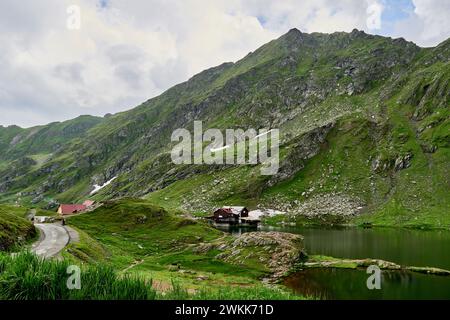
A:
[282,228,450,270]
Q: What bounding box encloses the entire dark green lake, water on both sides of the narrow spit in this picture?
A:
[214,226,450,299]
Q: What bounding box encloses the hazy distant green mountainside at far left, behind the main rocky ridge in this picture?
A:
[0,116,103,205]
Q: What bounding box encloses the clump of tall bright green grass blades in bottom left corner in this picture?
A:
[0,253,156,300]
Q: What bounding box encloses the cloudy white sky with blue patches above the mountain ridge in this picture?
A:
[0,0,450,127]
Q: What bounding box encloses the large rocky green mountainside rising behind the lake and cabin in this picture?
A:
[0,29,450,225]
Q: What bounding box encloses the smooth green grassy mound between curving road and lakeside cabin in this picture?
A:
[68,199,222,268]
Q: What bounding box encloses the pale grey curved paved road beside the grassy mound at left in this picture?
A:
[31,223,70,259]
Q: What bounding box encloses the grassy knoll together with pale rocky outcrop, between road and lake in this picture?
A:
[64,198,303,291]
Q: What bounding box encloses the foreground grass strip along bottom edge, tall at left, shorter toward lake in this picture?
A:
[0,253,300,300]
